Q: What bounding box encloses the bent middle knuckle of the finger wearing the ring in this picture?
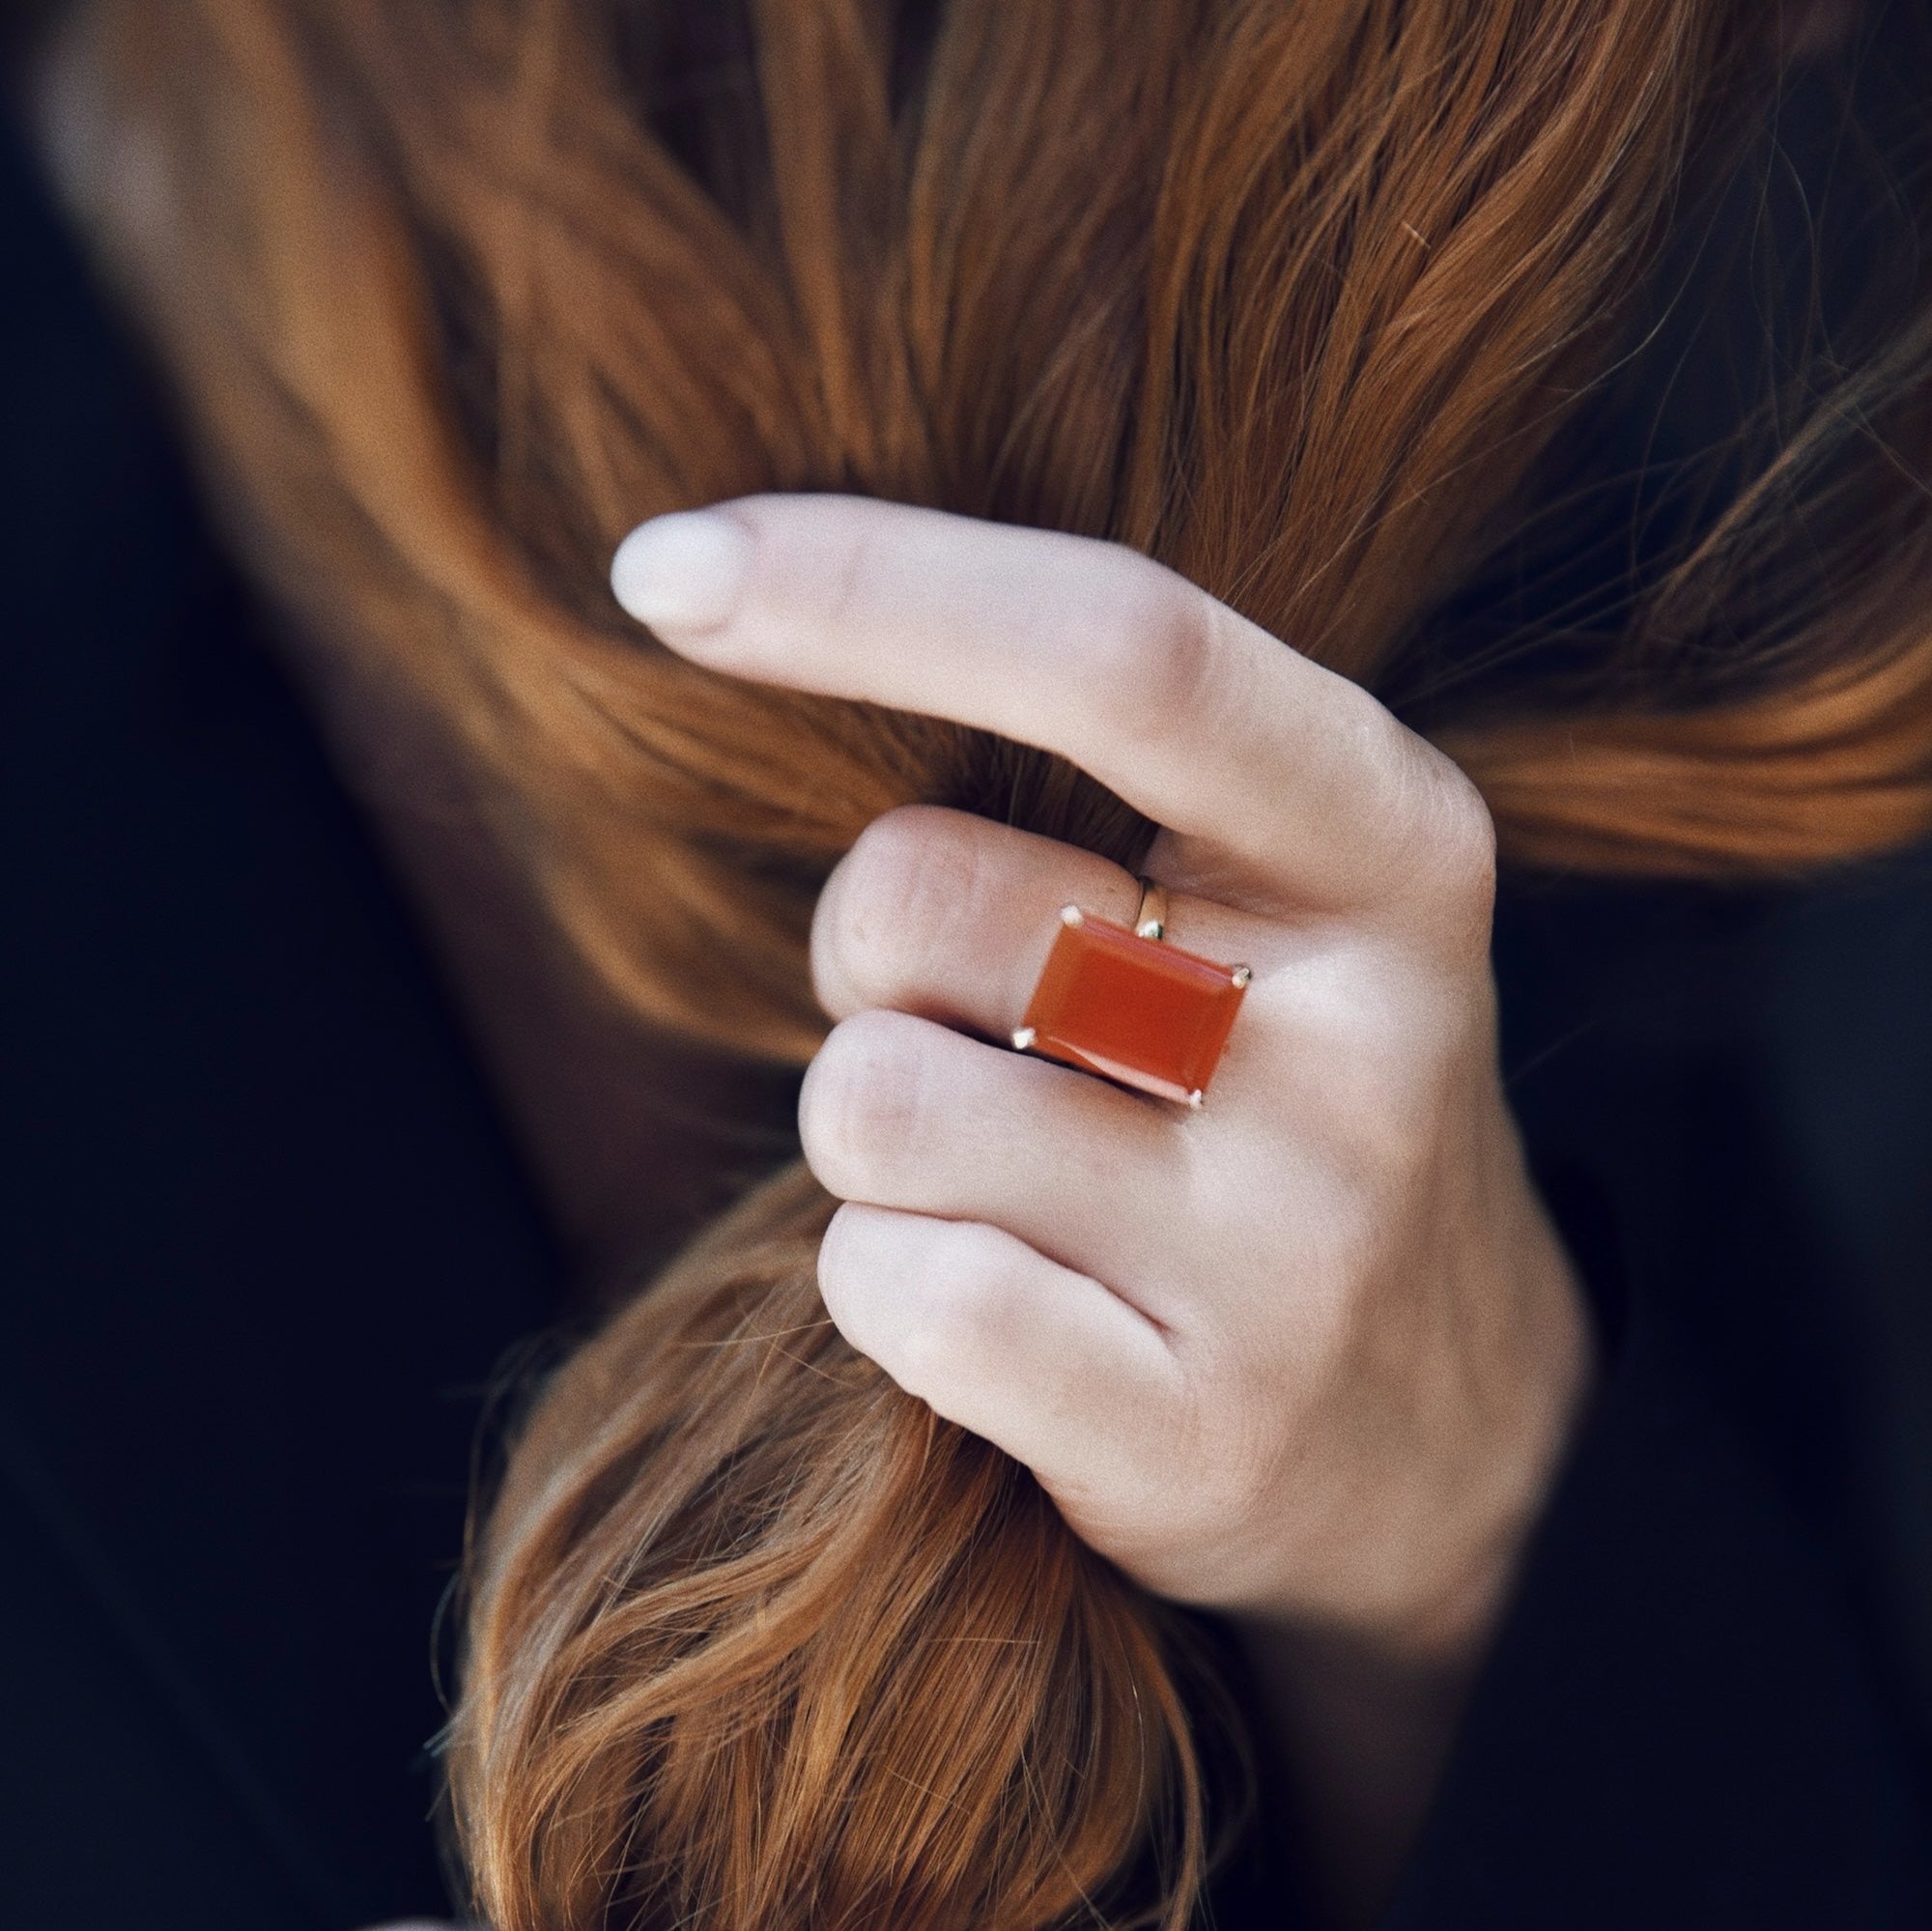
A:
[811,806,978,1011]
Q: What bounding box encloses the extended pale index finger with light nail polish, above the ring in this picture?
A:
[611,497,1445,904]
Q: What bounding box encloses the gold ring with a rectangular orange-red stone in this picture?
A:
[1012,879,1254,1106]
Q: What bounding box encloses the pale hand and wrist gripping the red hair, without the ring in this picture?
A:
[612,497,1590,1919]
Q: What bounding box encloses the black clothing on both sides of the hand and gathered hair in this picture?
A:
[0,124,1932,1931]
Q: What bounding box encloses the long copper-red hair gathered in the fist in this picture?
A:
[52,0,1932,1931]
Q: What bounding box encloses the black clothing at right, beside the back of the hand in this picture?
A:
[1391,884,1932,1927]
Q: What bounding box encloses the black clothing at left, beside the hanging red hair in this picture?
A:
[0,124,556,1931]
